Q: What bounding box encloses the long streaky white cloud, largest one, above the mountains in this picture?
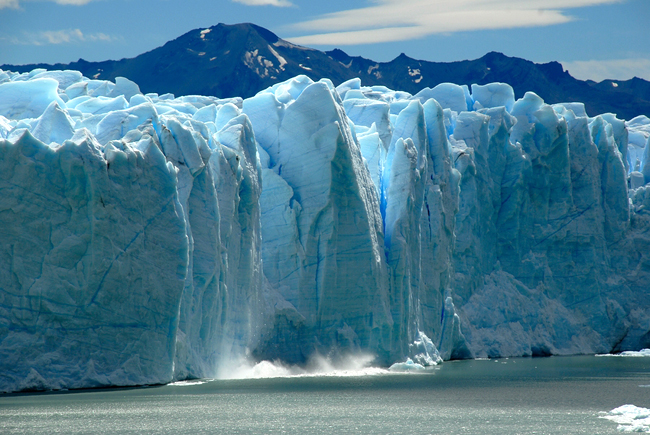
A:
[288,0,625,45]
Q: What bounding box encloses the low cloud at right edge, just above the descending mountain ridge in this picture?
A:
[561,58,650,82]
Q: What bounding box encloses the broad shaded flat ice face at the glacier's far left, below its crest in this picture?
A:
[0,124,187,390]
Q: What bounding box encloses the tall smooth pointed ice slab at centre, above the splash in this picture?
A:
[243,76,390,362]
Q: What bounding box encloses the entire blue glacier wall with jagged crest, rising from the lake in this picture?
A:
[0,70,650,391]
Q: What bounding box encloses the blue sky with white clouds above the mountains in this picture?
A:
[0,0,650,81]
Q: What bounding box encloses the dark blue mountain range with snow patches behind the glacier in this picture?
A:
[0,23,650,119]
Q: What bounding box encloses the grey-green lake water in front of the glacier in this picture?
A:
[0,356,650,435]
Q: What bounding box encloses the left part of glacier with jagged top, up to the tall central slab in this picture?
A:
[0,71,262,391]
